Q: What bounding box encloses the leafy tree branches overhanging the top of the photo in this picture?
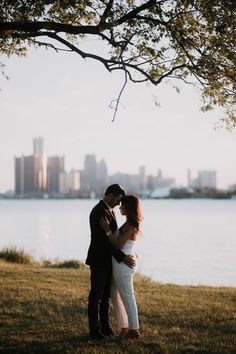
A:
[0,0,236,127]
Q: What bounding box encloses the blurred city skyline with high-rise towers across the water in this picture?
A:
[14,137,217,198]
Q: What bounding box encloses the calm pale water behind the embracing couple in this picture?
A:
[0,200,236,287]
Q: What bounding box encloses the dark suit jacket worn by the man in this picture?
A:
[85,200,125,267]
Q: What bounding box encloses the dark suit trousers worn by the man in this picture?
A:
[88,266,112,335]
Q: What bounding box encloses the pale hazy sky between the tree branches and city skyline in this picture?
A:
[0,41,236,192]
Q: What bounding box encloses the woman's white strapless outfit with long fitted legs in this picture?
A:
[111,231,139,330]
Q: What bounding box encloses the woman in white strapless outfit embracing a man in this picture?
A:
[100,195,142,339]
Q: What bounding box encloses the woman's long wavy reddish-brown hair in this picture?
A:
[121,194,142,231]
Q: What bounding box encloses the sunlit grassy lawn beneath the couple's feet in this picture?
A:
[0,250,236,354]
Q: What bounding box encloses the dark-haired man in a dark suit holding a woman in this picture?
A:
[86,184,135,340]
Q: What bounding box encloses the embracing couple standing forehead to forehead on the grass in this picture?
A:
[86,184,142,340]
